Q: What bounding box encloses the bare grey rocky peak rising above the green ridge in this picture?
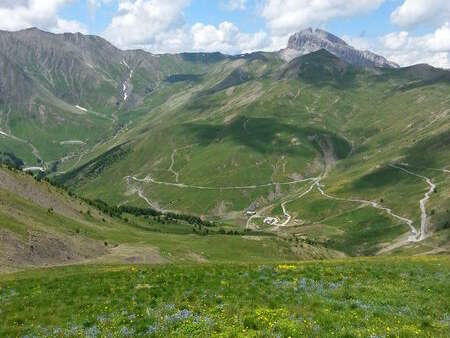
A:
[280,28,398,68]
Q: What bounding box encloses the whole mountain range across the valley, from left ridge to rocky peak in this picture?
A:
[0,28,450,255]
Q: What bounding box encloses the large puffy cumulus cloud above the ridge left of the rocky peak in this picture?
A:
[104,0,267,54]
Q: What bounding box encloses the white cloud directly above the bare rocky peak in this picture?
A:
[262,0,384,36]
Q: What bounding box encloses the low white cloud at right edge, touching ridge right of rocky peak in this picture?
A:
[378,22,450,68]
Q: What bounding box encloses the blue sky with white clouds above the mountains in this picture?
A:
[0,0,450,68]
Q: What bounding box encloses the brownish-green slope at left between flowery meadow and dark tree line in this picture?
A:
[0,169,342,270]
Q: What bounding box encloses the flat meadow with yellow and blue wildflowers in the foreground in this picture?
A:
[0,256,450,337]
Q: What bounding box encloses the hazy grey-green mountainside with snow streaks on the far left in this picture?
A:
[0,28,229,169]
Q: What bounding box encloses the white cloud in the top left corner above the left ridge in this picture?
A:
[0,0,87,32]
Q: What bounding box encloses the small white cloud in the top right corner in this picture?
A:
[391,0,450,27]
